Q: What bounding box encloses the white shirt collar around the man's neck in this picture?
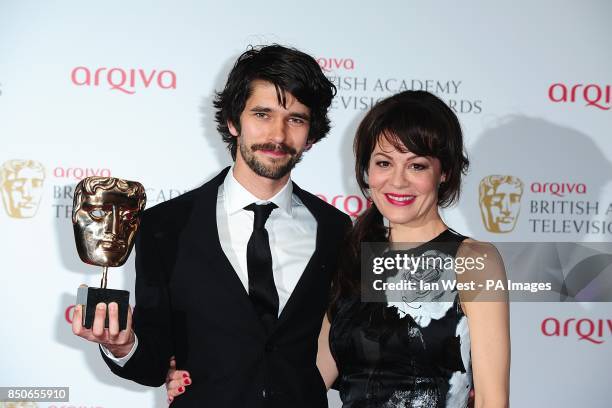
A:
[223,166,293,215]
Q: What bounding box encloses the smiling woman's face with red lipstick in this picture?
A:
[368,136,445,226]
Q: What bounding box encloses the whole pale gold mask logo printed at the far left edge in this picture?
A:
[0,160,45,218]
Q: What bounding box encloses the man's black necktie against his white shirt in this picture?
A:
[244,203,278,331]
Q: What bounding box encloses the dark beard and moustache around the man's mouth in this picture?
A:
[238,136,304,180]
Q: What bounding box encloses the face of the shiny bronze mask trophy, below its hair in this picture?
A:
[74,190,140,266]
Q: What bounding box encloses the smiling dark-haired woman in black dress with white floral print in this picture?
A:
[167,91,510,408]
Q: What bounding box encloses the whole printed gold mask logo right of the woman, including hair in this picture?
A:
[478,175,523,233]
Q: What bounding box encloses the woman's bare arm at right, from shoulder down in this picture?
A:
[457,240,510,408]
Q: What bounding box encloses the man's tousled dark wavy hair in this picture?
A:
[213,44,336,160]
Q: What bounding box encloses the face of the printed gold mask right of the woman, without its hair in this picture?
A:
[481,183,521,232]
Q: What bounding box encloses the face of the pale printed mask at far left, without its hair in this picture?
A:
[2,167,44,218]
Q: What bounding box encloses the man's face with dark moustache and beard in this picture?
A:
[228,80,310,180]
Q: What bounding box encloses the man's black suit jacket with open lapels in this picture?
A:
[103,168,350,408]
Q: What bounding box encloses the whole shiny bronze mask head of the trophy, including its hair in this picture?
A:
[72,177,146,266]
